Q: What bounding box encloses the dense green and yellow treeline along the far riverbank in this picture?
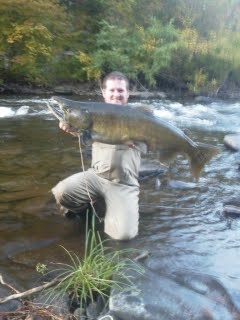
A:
[0,0,240,92]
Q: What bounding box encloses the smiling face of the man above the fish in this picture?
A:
[102,79,129,105]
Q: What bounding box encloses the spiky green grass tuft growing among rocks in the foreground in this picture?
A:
[41,212,144,307]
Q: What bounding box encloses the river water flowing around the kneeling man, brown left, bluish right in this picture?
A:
[0,96,240,307]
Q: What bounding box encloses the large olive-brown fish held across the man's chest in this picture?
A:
[48,97,219,178]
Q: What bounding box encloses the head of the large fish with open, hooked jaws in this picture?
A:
[48,97,92,132]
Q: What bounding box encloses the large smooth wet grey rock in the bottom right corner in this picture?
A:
[109,269,239,320]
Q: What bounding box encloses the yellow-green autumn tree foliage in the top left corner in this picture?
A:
[0,0,66,83]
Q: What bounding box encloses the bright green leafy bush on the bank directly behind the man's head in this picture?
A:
[82,18,178,87]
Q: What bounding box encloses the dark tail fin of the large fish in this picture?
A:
[190,143,220,180]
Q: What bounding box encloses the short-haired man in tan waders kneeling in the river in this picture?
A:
[52,72,144,240]
